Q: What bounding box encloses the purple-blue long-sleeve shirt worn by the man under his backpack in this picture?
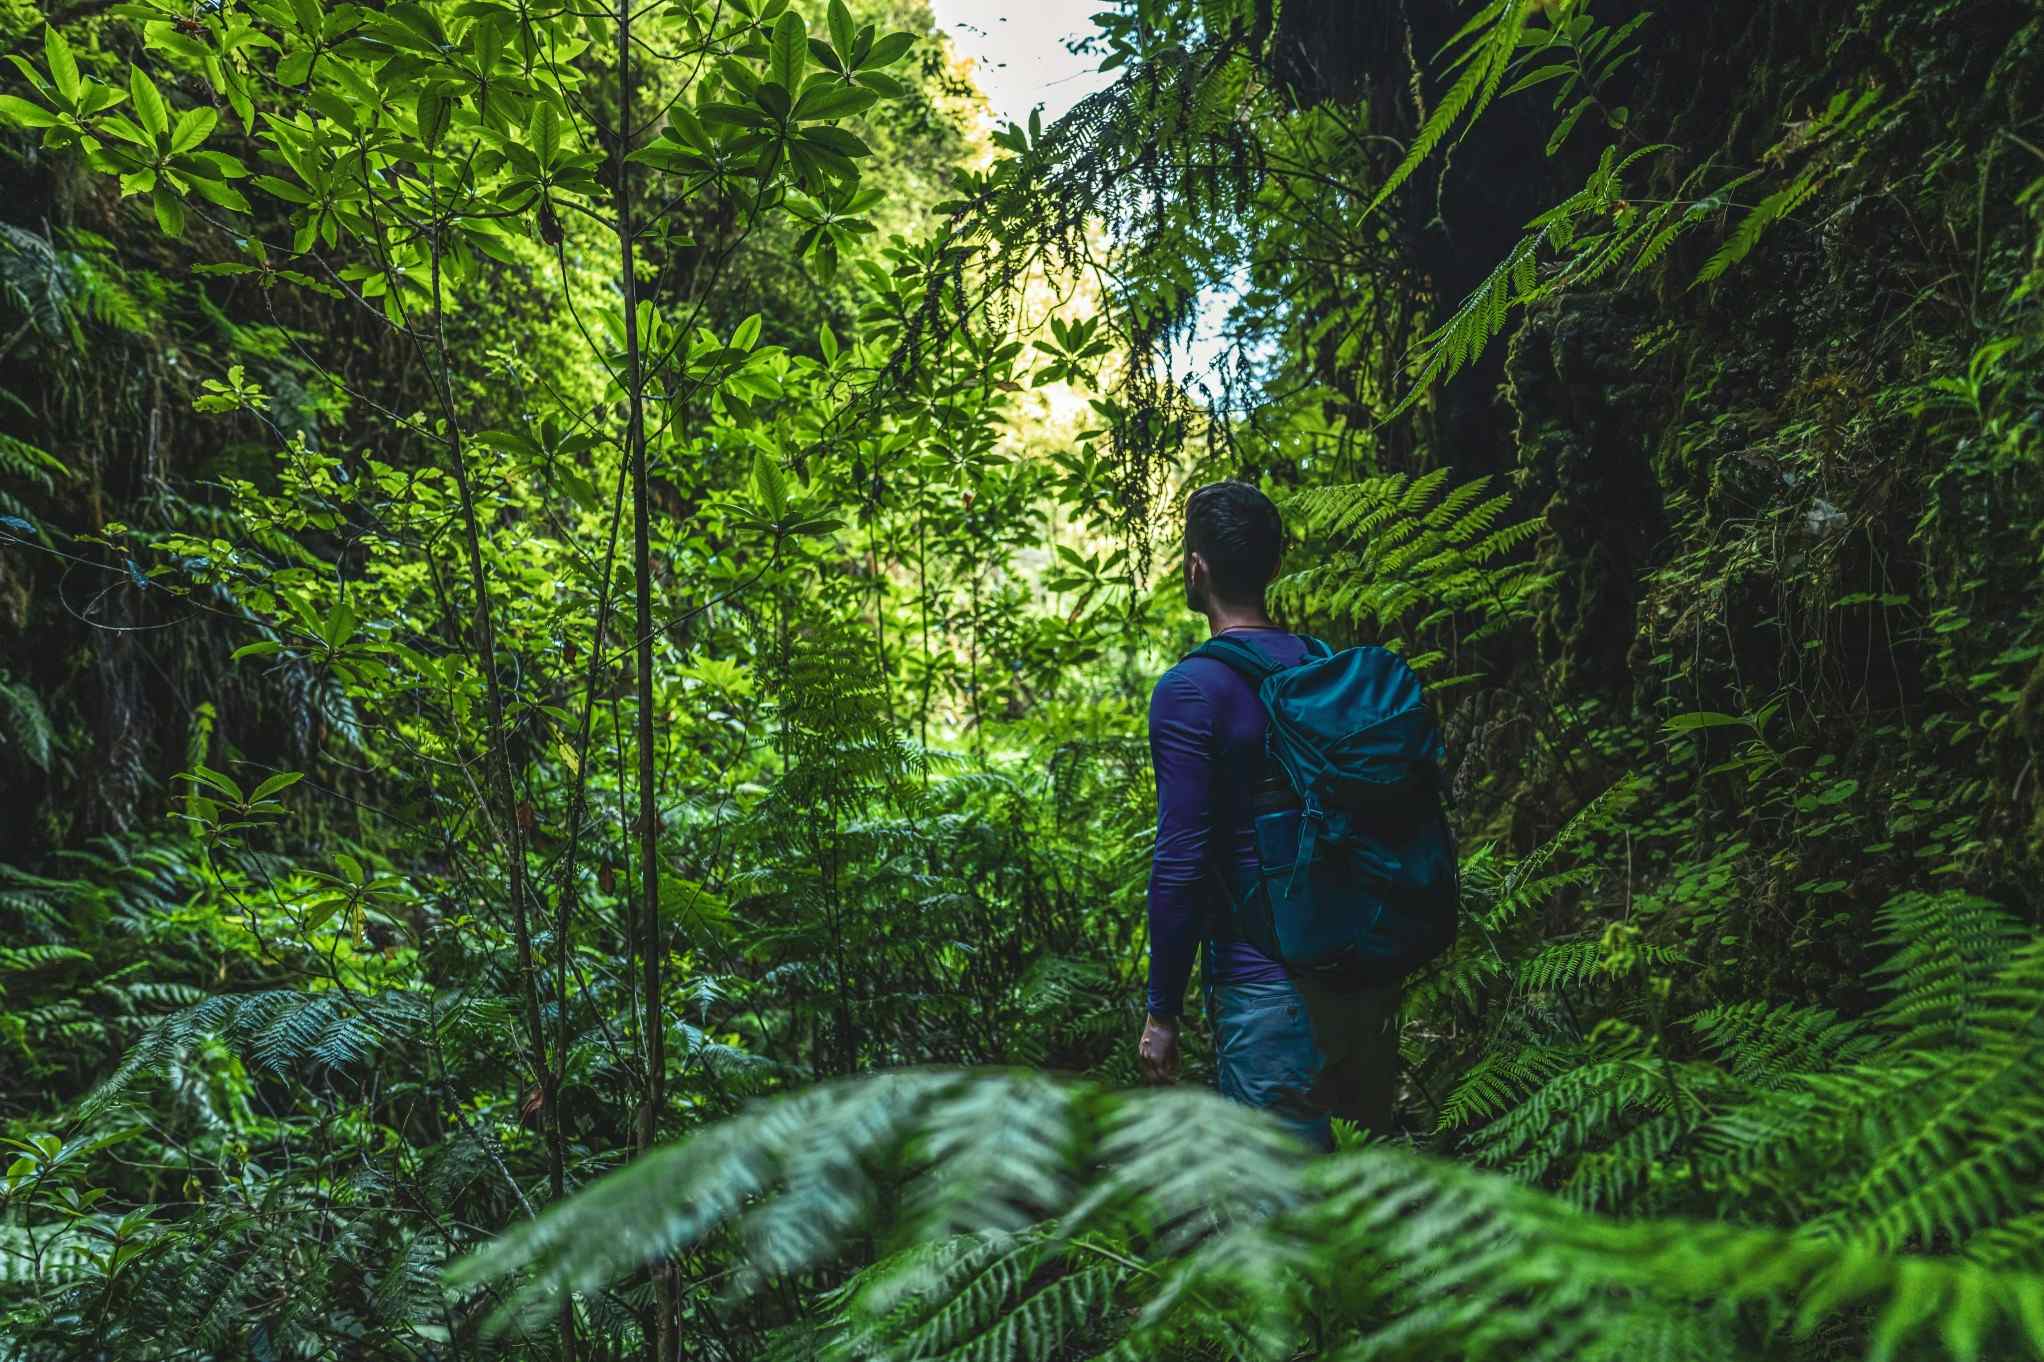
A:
[1149,628,1306,1016]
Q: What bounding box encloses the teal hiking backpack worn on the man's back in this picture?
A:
[1188,636,1461,986]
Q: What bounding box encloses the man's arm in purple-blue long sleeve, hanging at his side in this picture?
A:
[1149,671,1214,1023]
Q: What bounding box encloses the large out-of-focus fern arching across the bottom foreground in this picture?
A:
[454,1072,2044,1360]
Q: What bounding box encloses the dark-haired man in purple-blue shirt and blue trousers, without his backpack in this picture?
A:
[1139,483,1398,1149]
